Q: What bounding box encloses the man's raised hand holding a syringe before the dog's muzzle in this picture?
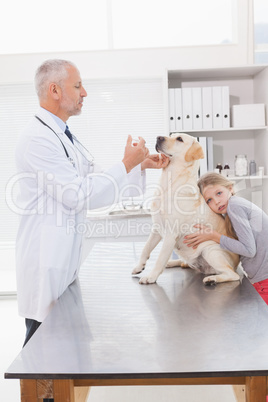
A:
[122,135,149,173]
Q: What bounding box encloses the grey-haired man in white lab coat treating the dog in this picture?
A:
[16,60,168,343]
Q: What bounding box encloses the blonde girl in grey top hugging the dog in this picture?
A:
[184,173,268,304]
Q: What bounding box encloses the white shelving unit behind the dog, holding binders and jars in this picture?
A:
[166,65,268,213]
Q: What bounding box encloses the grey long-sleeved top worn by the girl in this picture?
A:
[220,196,268,283]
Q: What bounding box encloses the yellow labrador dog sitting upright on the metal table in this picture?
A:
[132,133,240,284]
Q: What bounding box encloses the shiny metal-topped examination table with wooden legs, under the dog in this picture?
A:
[5,242,268,402]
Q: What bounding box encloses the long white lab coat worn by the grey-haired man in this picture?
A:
[16,108,142,322]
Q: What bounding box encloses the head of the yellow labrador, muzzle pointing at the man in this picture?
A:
[155,133,204,162]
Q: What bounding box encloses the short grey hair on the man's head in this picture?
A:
[35,59,76,99]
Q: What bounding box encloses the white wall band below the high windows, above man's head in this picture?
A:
[0,0,253,84]
